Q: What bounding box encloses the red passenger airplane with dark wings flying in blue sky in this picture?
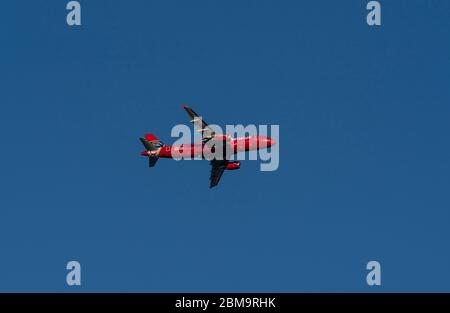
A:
[139,106,275,188]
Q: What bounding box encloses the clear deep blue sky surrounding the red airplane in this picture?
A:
[0,0,450,292]
